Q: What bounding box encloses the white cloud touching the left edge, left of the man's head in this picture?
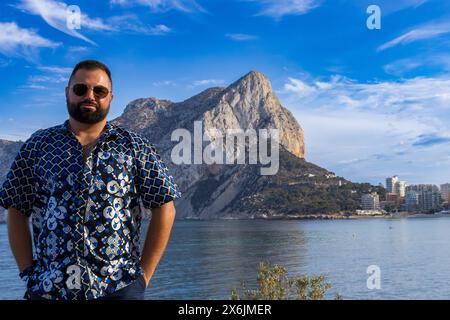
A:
[0,22,60,60]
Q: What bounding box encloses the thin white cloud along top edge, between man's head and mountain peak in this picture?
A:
[110,0,206,12]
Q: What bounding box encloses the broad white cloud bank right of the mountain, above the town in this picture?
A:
[280,76,450,183]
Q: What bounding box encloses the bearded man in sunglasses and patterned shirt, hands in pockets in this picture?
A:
[0,60,181,300]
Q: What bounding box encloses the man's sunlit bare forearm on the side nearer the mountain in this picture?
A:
[141,201,175,285]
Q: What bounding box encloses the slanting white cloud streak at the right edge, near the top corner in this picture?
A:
[377,22,450,51]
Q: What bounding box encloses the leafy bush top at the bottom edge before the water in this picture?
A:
[231,262,342,300]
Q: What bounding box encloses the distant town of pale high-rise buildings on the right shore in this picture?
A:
[357,176,450,215]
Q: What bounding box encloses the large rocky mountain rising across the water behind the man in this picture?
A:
[0,71,384,219]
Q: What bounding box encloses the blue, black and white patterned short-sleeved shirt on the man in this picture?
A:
[0,120,181,300]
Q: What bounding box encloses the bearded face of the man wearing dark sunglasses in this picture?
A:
[66,69,113,124]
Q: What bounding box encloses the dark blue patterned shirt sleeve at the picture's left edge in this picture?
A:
[0,134,36,216]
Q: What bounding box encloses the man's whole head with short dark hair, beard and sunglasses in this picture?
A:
[66,60,113,124]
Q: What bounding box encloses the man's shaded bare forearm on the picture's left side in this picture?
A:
[7,207,33,272]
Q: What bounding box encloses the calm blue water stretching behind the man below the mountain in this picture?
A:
[0,217,450,299]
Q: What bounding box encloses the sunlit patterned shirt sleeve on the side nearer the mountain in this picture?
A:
[136,139,181,209]
